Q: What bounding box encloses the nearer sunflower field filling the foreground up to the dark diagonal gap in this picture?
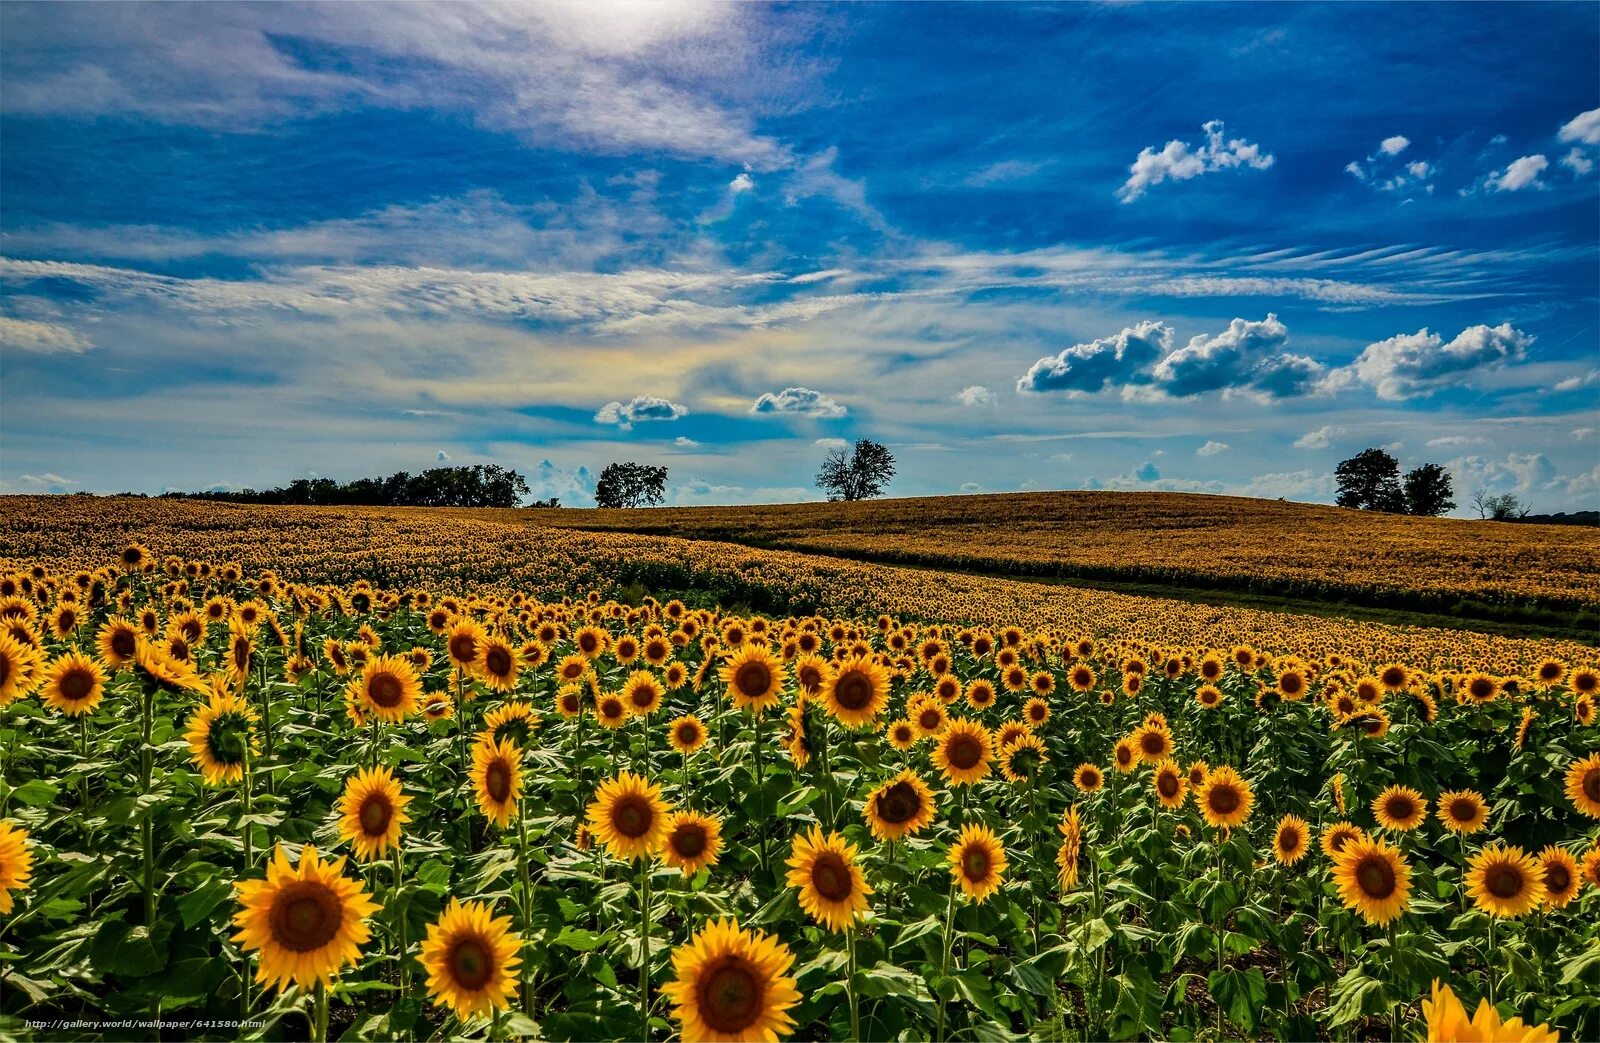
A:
[0,499,1600,1040]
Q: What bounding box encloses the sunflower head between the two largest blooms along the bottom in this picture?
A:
[418,897,522,1021]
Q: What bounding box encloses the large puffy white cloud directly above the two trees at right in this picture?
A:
[1330,323,1533,402]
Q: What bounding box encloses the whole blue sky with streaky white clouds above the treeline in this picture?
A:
[0,2,1600,510]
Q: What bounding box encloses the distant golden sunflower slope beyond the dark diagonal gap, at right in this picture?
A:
[531,493,1600,629]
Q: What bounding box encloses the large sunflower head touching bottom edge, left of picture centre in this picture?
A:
[661,920,800,1043]
